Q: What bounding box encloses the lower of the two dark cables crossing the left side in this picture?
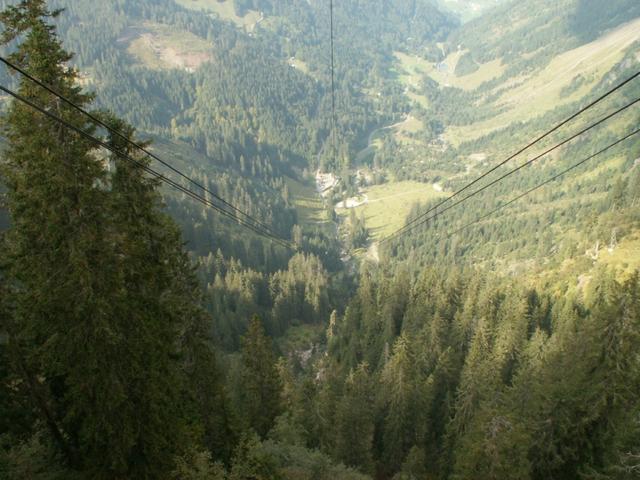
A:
[0,85,294,250]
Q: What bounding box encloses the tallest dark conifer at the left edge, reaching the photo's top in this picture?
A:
[0,0,114,466]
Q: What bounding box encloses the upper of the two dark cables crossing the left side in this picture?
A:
[0,56,278,240]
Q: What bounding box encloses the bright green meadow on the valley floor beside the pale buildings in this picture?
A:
[338,181,444,240]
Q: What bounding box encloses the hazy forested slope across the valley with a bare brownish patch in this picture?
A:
[0,0,454,270]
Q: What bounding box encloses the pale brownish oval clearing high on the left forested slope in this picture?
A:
[127,22,213,71]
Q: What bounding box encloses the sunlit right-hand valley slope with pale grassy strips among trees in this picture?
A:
[360,2,640,282]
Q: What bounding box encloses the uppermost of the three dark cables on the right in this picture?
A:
[380,71,640,244]
